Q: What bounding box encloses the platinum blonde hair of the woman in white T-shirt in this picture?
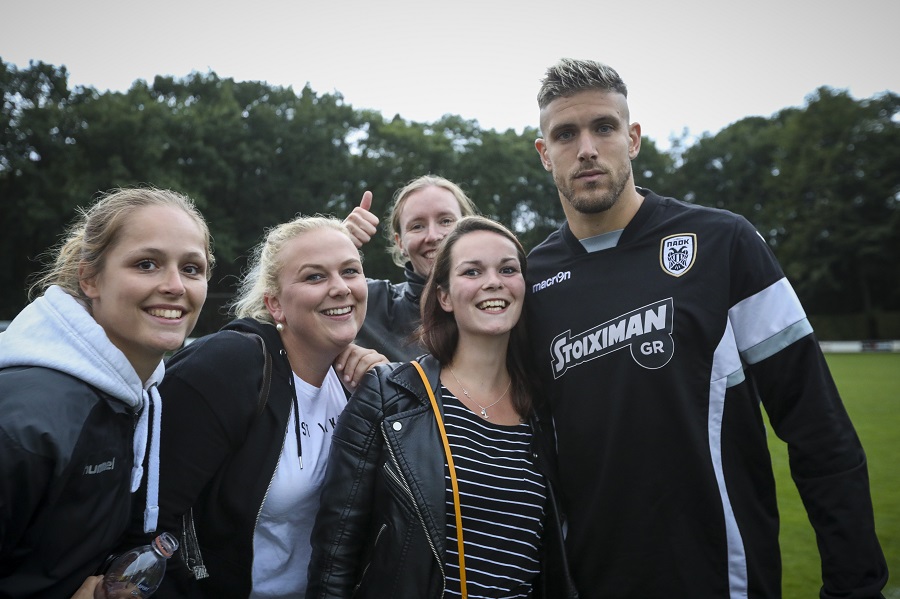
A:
[231,214,353,324]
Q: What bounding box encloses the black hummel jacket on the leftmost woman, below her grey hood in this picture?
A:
[0,367,137,599]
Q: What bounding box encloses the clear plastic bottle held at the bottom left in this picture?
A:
[94,532,178,599]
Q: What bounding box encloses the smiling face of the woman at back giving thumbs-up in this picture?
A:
[395,185,462,277]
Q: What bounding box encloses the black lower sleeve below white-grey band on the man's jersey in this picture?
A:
[754,334,888,599]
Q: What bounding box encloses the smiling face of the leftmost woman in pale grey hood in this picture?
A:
[81,206,208,380]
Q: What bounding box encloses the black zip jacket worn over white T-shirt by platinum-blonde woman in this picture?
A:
[125,318,294,598]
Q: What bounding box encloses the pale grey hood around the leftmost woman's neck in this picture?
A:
[0,285,165,410]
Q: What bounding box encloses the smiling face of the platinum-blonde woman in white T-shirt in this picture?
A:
[265,228,368,364]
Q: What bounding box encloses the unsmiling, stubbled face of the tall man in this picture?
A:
[535,90,641,227]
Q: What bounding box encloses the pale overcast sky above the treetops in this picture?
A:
[0,0,900,147]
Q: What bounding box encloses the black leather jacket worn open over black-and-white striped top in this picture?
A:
[306,356,577,599]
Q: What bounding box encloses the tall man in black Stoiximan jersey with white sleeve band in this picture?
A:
[526,60,888,599]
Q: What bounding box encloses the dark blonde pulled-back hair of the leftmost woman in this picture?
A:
[28,187,215,308]
